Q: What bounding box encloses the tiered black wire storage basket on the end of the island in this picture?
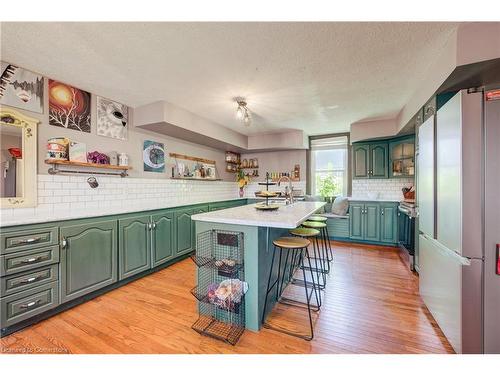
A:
[191,230,248,345]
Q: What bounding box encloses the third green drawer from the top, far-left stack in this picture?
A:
[0,264,59,297]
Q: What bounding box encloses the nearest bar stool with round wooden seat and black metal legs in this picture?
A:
[262,237,319,341]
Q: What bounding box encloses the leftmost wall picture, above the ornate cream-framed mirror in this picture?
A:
[0,62,44,113]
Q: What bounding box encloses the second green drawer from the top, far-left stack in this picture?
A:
[0,245,59,276]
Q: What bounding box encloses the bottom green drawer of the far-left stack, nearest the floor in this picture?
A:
[0,281,59,328]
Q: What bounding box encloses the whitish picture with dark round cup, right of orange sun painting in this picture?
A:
[97,96,128,140]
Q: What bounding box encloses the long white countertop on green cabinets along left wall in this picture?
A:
[0,198,246,228]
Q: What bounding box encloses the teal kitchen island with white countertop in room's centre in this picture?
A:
[191,202,325,331]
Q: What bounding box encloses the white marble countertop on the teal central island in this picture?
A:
[191,202,326,229]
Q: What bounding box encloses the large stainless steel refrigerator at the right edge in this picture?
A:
[417,86,500,353]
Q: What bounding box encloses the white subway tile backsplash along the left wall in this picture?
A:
[0,175,242,225]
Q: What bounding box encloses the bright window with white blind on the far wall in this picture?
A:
[310,135,349,197]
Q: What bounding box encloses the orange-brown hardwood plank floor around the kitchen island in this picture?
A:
[0,242,453,354]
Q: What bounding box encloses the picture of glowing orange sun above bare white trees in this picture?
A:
[49,79,90,133]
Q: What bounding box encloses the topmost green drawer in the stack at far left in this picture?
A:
[0,227,59,255]
